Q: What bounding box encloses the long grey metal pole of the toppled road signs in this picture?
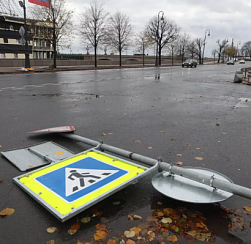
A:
[60,133,251,199]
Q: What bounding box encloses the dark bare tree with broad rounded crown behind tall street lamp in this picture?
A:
[146,17,180,65]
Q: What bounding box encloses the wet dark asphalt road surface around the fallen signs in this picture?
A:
[0,63,251,244]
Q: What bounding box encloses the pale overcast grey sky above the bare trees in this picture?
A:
[27,0,251,57]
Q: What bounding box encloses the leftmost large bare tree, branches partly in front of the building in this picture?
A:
[31,0,73,68]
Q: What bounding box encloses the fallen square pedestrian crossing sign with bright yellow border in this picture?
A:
[14,150,150,222]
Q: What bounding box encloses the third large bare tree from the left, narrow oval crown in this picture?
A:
[106,11,133,66]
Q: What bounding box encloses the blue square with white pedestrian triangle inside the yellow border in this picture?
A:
[35,157,129,202]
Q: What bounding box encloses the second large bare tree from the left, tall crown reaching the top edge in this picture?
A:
[79,0,108,67]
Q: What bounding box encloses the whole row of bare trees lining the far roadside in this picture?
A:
[28,0,251,68]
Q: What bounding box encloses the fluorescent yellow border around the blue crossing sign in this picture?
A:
[19,151,146,215]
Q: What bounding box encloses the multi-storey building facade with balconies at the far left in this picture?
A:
[0,16,53,59]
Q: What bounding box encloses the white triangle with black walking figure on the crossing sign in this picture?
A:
[65,168,118,197]
